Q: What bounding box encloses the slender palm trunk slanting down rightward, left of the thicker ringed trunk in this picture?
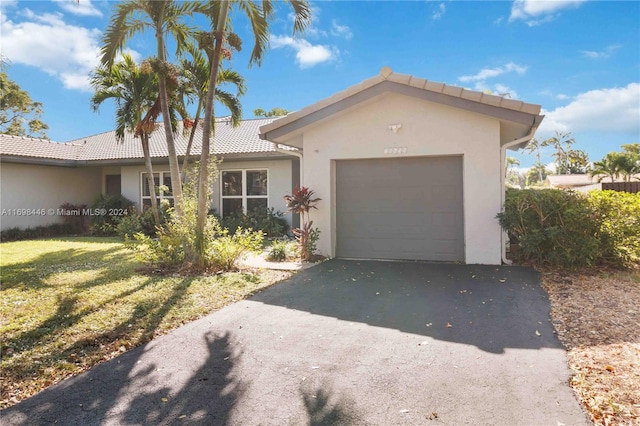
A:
[156,6,182,218]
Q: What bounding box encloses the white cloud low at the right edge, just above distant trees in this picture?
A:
[540,83,640,135]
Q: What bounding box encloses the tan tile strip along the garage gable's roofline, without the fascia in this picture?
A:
[260,66,541,137]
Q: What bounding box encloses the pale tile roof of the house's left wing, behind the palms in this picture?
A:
[0,118,280,165]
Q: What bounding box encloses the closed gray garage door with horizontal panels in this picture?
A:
[336,157,464,261]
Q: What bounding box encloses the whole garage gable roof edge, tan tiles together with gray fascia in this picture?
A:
[260,67,544,143]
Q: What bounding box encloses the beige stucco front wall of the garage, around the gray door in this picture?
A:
[302,93,501,264]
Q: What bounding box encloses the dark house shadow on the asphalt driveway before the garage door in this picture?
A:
[252,259,562,353]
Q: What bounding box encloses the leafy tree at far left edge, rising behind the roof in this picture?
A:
[0,71,49,139]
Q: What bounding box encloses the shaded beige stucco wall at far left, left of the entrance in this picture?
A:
[0,163,102,229]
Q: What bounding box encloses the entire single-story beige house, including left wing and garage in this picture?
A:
[0,67,544,264]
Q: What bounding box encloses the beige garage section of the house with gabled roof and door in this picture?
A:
[260,67,543,264]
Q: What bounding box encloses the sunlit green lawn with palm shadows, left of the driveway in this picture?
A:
[0,237,286,408]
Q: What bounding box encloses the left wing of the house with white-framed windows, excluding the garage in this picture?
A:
[0,118,300,233]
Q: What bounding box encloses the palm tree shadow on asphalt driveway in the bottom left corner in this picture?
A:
[2,332,245,425]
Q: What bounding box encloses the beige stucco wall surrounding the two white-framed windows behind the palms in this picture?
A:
[120,160,292,224]
